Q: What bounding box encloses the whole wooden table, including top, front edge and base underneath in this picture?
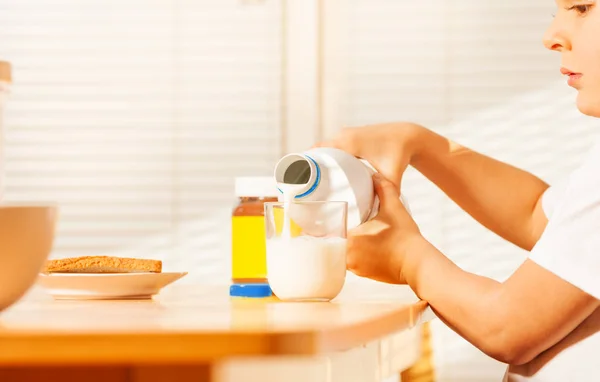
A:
[0,284,427,382]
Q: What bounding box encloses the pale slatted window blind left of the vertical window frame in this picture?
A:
[0,0,282,277]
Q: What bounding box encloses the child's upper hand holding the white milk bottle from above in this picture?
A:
[317,122,425,188]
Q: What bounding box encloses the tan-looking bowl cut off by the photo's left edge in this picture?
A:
[0,204,57,311]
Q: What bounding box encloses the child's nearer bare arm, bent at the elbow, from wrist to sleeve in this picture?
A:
[402,239,600,365]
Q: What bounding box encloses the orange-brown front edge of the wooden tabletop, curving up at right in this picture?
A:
[0,301,428,366]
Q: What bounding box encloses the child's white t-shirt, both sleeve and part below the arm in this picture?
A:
[505,143,600,382]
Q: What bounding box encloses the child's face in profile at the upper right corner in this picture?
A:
[544,0,600,117]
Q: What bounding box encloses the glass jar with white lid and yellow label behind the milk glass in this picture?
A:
[231,177,278,285]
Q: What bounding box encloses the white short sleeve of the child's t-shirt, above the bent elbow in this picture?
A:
[530,145,600,298]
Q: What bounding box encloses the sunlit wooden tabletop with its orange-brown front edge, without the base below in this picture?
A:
[0,284,427,366]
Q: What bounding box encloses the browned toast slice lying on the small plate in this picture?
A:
[43,256,162,273]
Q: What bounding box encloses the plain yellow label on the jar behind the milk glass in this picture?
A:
[231,216,267,279]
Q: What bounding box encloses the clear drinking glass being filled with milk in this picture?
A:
[265,201,348,301]
